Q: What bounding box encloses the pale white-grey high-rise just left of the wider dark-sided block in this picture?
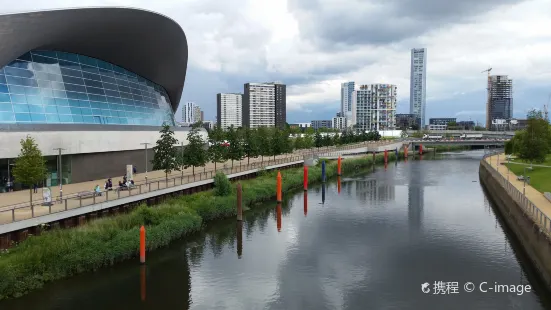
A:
[216,93,243,130]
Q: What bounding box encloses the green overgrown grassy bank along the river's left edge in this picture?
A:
[0,153,395,300]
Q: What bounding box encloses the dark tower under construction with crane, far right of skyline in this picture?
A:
[486,75,513,130]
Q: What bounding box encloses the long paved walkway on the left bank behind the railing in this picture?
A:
[0,141,389,211]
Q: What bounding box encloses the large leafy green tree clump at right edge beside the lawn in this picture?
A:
[505,110,551,163]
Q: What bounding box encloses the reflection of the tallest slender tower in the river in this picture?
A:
[408,165,425,231]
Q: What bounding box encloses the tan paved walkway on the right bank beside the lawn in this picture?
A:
[485,153,551,229]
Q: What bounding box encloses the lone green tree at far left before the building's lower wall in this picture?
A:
[12,136,48,204]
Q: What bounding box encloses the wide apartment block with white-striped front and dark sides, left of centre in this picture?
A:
[246,82,287,129]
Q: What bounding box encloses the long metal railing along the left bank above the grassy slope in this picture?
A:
[0,142,384,225]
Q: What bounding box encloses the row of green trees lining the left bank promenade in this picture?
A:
[153,123,381,177]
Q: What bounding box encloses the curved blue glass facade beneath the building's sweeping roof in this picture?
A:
[0,50,174,126]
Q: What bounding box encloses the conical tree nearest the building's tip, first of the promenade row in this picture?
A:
[151,124,180,183]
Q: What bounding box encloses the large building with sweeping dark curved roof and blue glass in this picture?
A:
[0,7,203,191]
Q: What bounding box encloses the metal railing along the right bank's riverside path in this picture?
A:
[482,151,551,237]
